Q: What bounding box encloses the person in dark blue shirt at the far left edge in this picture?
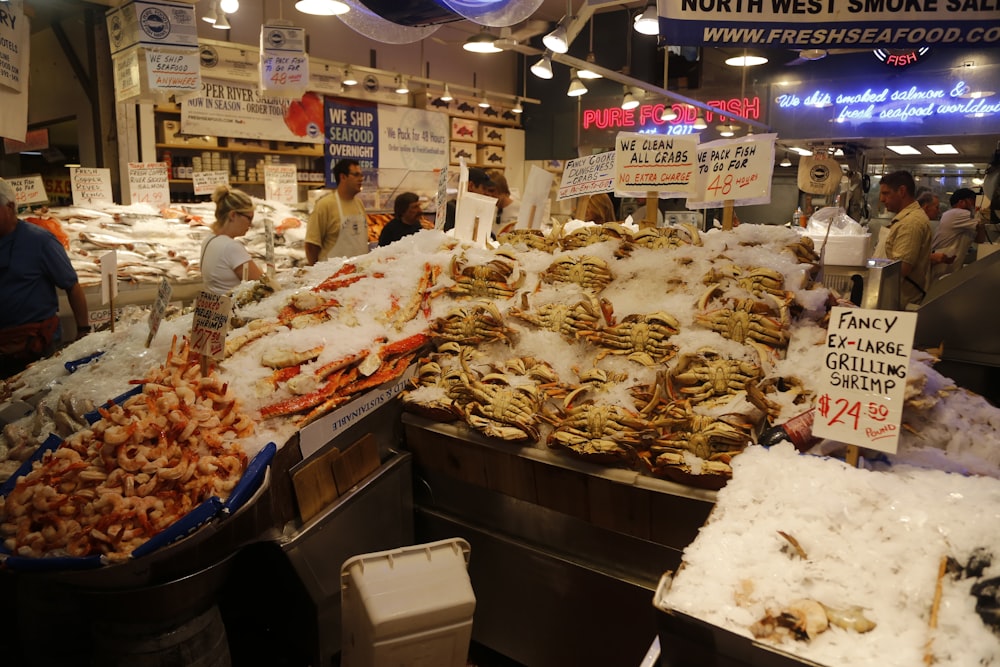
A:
[0,179,90,377]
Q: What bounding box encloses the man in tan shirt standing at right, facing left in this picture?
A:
[878,171,931,306]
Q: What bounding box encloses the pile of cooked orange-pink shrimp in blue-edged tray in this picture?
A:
[0,339,254,562]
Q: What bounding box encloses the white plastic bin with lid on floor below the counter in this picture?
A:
[340,538,476,667]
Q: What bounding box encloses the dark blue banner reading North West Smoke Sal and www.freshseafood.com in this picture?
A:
[657,0,1000,49]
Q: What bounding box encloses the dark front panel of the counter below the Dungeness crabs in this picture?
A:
[402,413,716,666]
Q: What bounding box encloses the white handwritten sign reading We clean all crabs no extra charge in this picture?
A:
[615,132,698,197]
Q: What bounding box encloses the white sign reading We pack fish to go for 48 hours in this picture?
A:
[687,134,778,209]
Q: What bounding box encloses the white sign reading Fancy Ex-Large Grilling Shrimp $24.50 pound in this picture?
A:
[813,306,917,453]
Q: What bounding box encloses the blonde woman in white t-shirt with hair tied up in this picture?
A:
[201,185,263,294]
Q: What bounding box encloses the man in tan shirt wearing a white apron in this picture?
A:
[306,159,368,266]
